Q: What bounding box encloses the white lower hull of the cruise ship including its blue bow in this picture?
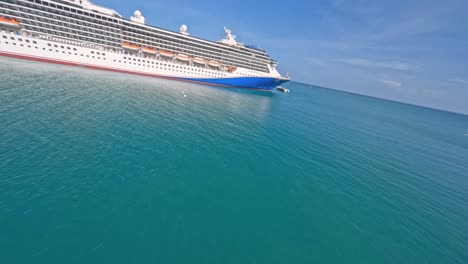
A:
[0,31,287,90]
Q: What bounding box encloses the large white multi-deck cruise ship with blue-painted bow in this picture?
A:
[0,0,289,91]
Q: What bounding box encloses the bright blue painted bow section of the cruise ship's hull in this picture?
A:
[182,77,289,91]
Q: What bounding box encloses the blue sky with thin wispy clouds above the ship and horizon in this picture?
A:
[94,0,468,114]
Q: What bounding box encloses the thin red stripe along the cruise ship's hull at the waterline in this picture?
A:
[0,51,268,91]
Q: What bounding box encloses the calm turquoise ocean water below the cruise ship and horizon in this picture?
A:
[0,59,468,264]
